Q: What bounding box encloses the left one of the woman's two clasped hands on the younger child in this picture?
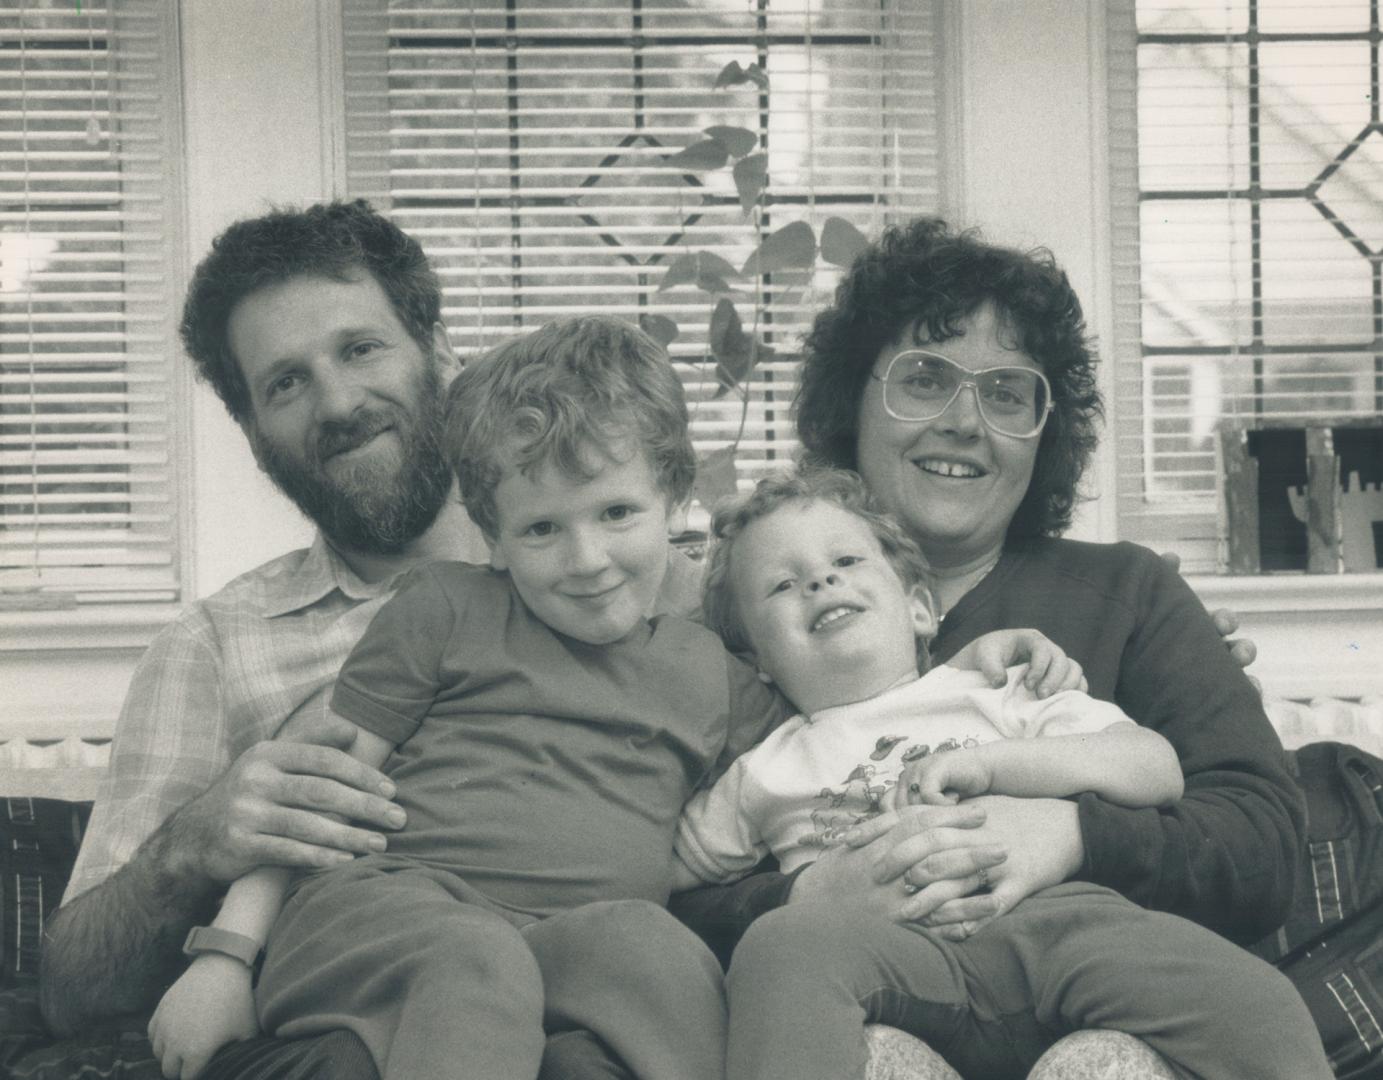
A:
[788,802,1008,922]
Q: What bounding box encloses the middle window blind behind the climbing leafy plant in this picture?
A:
[344,0,939,522]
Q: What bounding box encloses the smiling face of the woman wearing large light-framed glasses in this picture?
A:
[856,304,1041,567]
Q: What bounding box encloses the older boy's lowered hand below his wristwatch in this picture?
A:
[149,953,259,1080]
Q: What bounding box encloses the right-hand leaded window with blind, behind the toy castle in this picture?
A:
[1109,0,1383,572]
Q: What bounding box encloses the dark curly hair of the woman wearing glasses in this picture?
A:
[794,217,1102,538]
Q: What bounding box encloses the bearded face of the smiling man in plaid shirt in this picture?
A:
[227,271,452,555]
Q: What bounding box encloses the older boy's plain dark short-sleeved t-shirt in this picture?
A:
[332,563,790,915]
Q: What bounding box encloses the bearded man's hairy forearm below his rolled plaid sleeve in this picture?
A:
[39,817,220,1036]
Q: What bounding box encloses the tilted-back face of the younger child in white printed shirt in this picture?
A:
[730,499,931,712]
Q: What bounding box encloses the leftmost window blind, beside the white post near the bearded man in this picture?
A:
[0,0,178,607]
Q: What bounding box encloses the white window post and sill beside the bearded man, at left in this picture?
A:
[0,0,343,740]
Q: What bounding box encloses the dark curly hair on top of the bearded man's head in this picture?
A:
[180,199,441,423]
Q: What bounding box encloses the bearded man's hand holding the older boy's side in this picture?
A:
[167,718,404,882]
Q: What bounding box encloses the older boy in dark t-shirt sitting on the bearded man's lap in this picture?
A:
[151,318,784,1080]
